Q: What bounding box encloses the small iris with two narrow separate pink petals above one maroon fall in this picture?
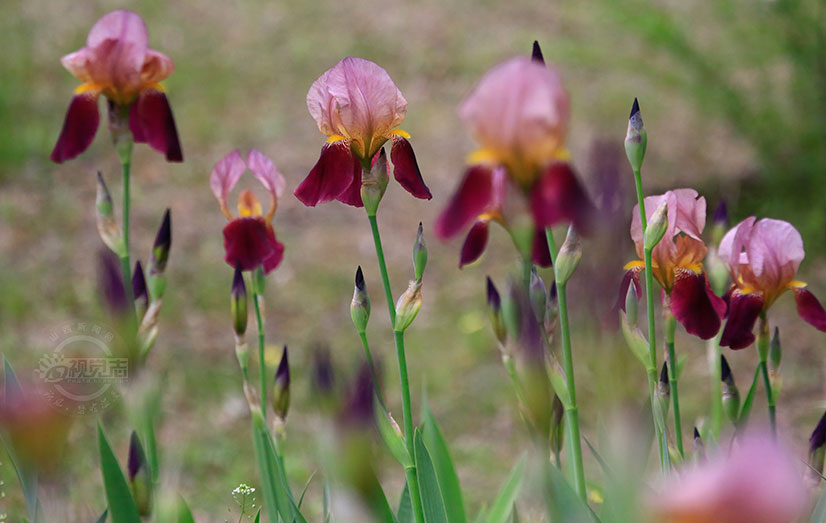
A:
[209,149,286,273]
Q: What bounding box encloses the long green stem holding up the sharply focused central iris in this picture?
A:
[367,214,424,523]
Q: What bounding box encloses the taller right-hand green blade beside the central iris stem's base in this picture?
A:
[422,406,467,523]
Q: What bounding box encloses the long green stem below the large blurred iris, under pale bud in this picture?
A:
[545,229,587,500]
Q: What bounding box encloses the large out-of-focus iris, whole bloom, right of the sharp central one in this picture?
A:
[436,51,592,267]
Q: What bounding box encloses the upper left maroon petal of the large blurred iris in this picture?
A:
[436,165,493,239]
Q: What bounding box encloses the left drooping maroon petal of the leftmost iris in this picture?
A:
[50,91,100,163]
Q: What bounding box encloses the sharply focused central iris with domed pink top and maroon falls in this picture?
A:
[295,57,432,207]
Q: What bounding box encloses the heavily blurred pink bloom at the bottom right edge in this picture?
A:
[651,435,806,523]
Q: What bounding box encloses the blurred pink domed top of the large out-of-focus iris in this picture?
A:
[460,57,570,172]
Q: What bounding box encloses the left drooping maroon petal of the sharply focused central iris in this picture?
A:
[293,140,361,207]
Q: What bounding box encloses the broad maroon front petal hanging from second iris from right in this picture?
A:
[671,269,726,340]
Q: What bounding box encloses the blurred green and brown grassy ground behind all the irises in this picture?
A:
[0,0,826,521]
